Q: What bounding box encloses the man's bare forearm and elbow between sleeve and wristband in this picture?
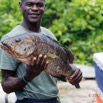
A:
[1,69,26,93]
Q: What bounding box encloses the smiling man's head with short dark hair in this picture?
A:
[20,0,45,23]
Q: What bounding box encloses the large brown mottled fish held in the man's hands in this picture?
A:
[1,33,80,88]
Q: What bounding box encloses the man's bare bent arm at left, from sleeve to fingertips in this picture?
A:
[1,54,48,93]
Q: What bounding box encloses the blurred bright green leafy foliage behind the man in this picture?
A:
[0,0,103,65]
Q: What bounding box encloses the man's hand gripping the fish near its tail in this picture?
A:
[67,69,82,85]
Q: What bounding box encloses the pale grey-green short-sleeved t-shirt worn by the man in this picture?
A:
[0,25,58,100]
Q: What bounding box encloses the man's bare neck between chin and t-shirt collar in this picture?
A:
[21,22,41,32]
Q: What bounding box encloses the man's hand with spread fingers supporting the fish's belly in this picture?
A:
[24,54,48,81]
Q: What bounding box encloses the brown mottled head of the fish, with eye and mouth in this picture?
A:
[1,34,36,62]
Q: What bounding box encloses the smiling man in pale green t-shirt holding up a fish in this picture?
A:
[0,0,82,103]
